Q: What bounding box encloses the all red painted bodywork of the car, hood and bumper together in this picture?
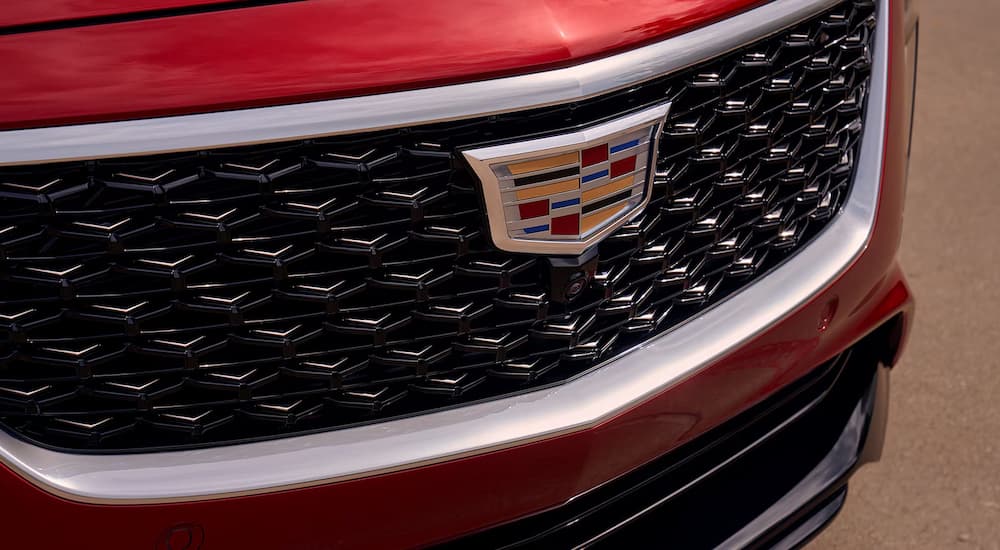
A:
[0,0,913,549]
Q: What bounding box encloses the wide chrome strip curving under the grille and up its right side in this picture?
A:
[0,0,889,504]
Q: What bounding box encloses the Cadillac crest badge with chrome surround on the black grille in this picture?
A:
[464,102,670,255]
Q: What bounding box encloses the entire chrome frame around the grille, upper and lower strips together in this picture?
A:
[0,0,889,504]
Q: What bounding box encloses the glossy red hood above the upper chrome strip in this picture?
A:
[0,0,760,128]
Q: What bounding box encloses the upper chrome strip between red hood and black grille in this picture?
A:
[0,0,838,166]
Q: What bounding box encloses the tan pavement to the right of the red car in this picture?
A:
[809,0,1000,550]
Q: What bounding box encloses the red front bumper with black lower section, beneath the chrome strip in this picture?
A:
[0,262,912,548]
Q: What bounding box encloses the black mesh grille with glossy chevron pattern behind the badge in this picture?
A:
[0,0,875,452]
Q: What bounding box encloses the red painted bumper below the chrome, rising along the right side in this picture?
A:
[0,0,912,549]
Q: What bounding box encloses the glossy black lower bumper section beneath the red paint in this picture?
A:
[451,328,899,548]
